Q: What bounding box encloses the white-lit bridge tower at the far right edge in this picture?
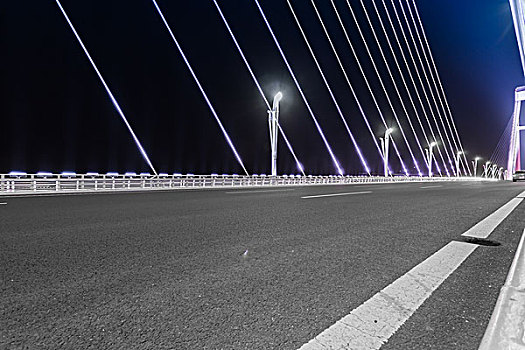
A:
[506,0,525,180]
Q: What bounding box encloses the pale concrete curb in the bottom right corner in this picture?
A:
[479,230,525,350]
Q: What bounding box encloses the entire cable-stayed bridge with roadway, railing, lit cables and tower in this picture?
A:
[0,0,525,349]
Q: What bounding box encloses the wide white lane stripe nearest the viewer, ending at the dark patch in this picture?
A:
[300,241,478,350]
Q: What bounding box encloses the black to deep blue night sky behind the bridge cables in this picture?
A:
[0,0,523,174]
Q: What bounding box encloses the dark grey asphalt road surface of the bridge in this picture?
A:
[0,182,525,349]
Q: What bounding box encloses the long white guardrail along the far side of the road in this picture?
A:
[0,172,490,194]
